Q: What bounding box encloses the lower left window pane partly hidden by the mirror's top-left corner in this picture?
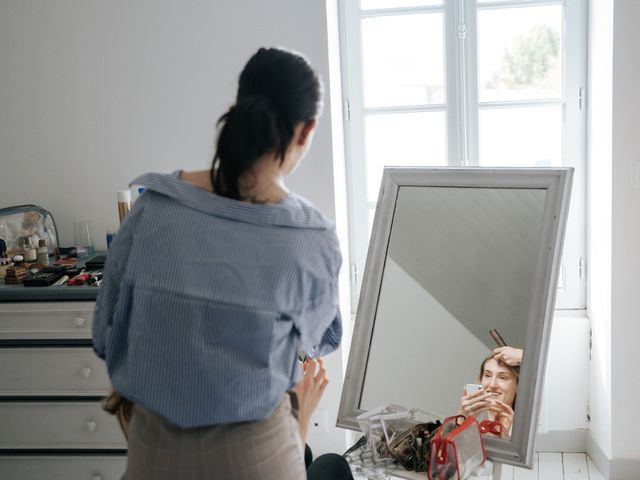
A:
[365,112,446,202]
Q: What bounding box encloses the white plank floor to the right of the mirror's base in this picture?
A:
[500,453,604,480]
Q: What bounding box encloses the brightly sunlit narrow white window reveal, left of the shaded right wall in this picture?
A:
[587,0,613,468]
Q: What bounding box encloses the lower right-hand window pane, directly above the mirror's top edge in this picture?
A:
[479,105,563,167]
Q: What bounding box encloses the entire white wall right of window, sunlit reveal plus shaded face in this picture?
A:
[588,0,640,479]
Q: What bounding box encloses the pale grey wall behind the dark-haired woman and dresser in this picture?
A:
[0,0,348,453]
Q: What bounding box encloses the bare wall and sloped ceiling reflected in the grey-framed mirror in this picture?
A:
[359,187,546,417]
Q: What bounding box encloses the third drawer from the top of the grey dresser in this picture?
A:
[0,402,126,449]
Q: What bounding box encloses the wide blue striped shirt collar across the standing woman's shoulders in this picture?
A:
[130,173,333,230]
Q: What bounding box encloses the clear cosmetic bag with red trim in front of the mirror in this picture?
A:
[428,415,487,480]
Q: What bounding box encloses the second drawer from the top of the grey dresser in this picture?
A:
[0,347,110,397]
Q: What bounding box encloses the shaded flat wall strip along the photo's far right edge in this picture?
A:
[611,0,640,468]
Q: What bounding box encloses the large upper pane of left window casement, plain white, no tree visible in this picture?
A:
[362,13,444,107]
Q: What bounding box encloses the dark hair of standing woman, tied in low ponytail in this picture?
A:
[211,48,322,200]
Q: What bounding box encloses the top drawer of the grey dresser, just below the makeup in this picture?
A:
[0,302,95,340]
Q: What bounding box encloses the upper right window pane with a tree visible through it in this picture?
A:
[478,5,563,102]
